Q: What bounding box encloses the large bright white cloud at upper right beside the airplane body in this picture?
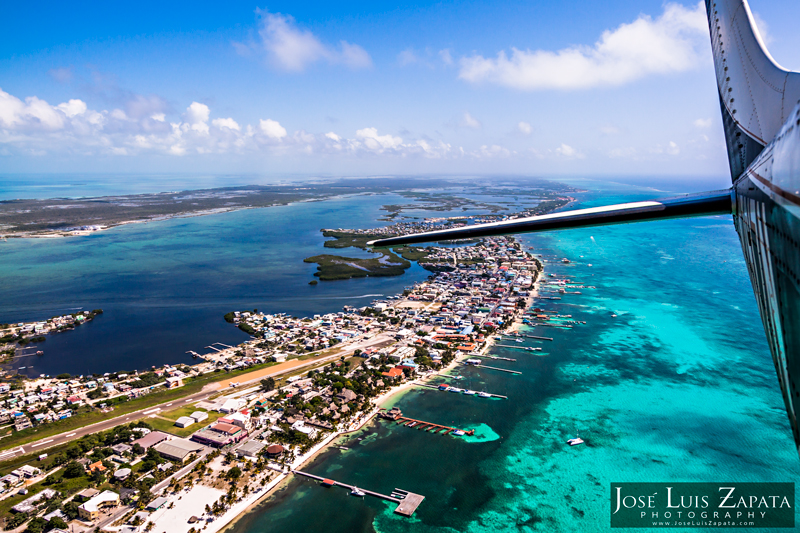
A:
[459,2,708,91]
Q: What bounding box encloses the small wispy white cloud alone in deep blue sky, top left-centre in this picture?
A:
[253,10,372,72]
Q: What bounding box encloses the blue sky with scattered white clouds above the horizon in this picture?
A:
[0,0,800,177]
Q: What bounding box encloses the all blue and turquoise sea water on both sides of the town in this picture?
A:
[0,176,800,533]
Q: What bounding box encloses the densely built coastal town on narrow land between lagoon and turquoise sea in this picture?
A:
[0,237,542,533]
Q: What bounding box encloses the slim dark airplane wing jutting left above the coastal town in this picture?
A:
[368,189,733,248]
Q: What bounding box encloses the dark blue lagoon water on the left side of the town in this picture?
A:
[0,195,438,375]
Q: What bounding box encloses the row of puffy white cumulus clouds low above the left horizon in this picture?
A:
[0,89,482,159]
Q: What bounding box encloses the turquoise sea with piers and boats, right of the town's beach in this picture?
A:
[225,185,800,533]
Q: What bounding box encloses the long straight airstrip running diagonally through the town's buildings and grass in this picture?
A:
[0,333,392,461]
